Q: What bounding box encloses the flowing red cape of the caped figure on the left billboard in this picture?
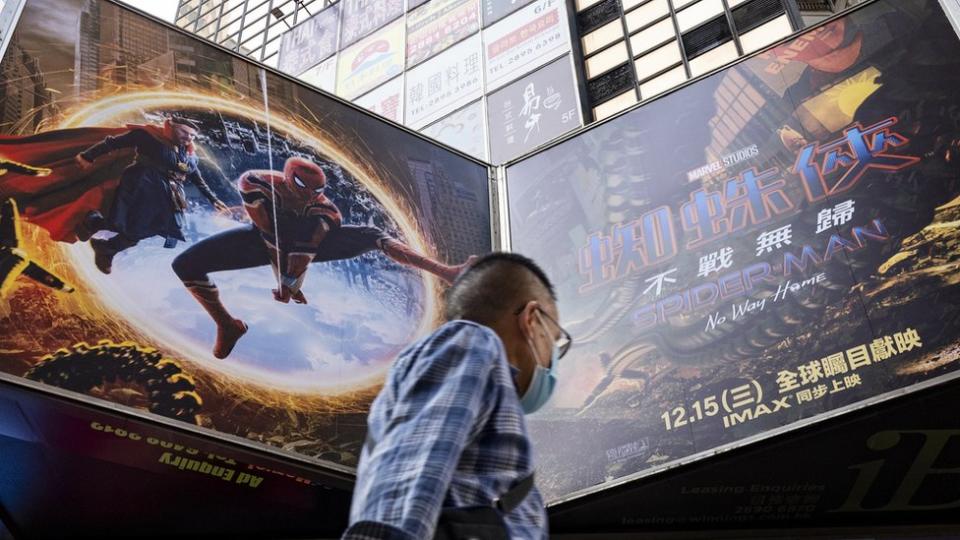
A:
[0,127,134,243]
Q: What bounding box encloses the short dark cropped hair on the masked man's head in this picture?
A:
[445,252,557,326]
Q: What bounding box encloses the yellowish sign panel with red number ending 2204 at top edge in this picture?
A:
[407,0,480,69]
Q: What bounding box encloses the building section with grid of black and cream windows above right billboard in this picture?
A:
[575,0,800,120]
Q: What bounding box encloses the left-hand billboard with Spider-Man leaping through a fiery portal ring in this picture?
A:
[0,0,490,472]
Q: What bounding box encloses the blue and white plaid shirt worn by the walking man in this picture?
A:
[343,321,547,540]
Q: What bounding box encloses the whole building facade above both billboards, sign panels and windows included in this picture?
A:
[176,0,872,164]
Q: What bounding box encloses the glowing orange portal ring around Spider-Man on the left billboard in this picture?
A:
[59,91,439,393]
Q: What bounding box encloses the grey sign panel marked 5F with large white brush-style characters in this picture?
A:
[487,56,581,163]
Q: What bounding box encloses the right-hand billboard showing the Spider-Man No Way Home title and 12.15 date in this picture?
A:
[507,0,960,500]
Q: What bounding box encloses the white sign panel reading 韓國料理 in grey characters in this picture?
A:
[404,34,483,129]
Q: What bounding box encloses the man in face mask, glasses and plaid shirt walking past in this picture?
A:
[343,253,570,540]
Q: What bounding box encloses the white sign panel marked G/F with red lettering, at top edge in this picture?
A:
[483,0,570,91]
